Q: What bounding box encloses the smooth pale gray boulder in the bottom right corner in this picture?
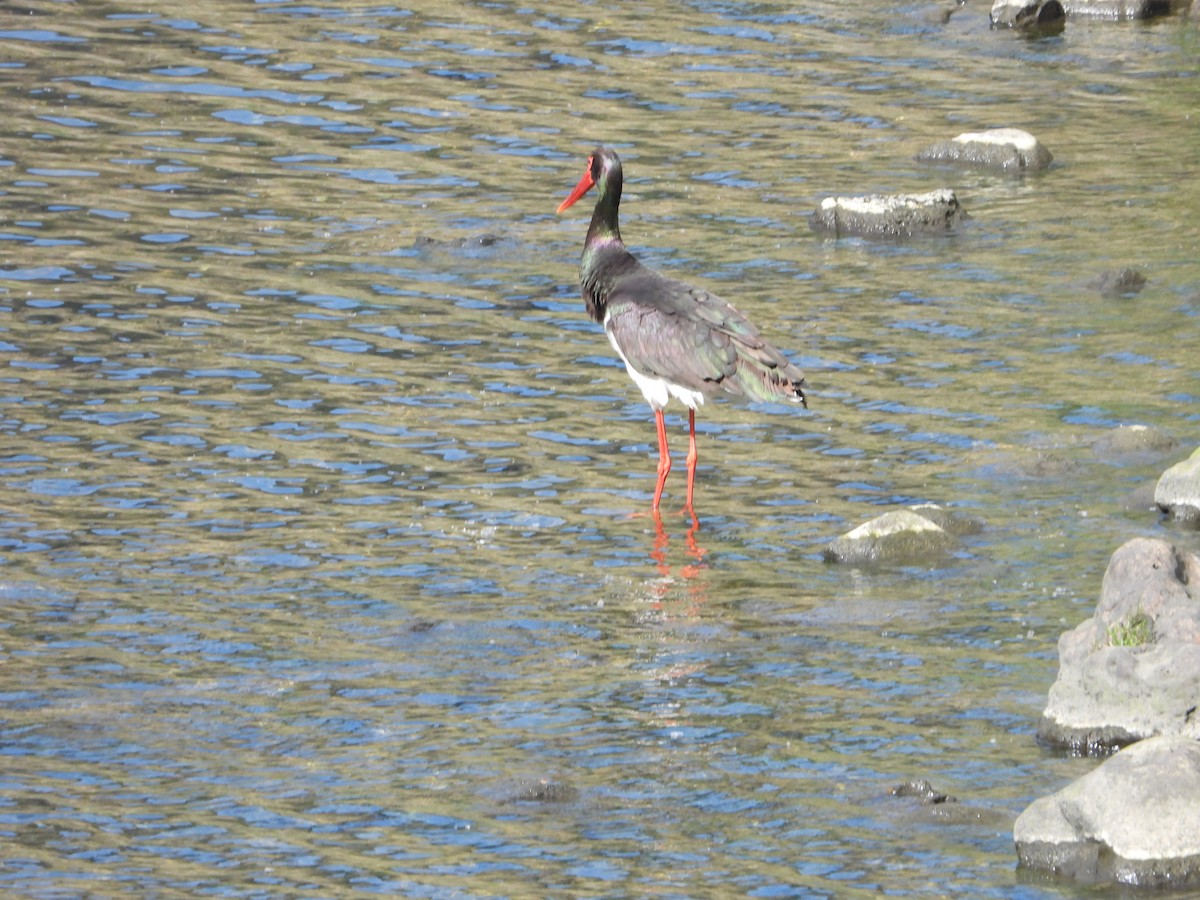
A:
[1013,737,1200,888]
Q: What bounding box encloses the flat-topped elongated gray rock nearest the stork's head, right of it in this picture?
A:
[809,187,966,238]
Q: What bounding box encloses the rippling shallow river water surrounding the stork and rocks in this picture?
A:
[0,2,1200,896]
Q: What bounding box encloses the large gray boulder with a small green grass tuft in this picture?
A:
[1038,538,1200,755]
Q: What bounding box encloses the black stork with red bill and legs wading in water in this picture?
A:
[558,146,808,522]
